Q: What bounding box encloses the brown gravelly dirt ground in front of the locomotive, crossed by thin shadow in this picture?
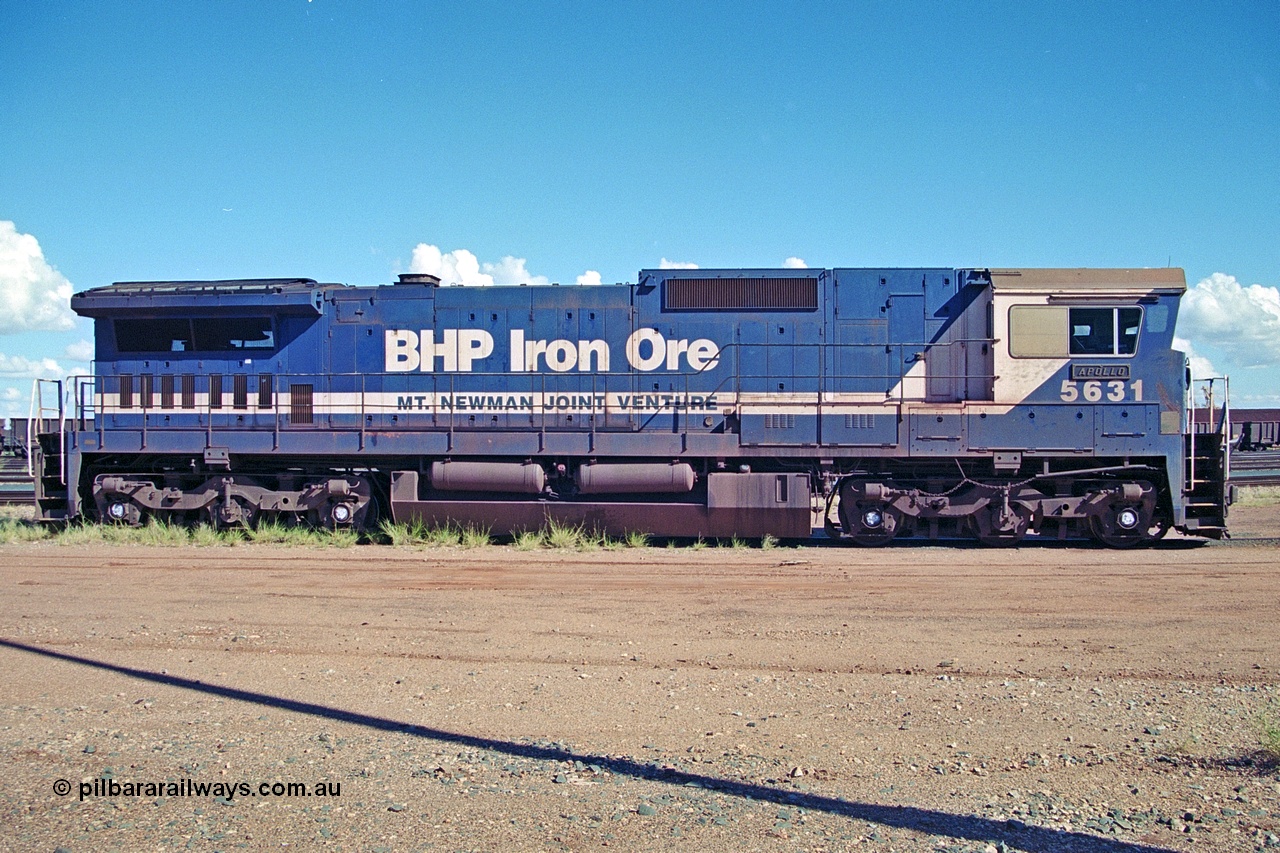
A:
[0,507,1280,853]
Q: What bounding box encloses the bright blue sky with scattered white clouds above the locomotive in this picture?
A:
[0,0,1280,415]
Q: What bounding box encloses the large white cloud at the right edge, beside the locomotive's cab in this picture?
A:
[1178,273,1280,368]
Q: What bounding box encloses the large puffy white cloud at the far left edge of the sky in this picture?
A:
[0,220,76,334]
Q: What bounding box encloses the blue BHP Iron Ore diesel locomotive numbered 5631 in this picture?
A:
[35,263,1229,547]
